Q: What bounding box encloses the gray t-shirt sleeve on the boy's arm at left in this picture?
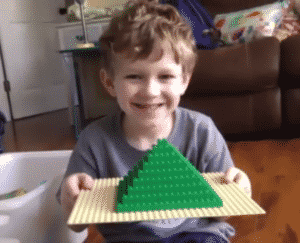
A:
[56,130,99,204]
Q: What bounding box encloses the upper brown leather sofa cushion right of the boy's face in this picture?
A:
[185,37,280,97]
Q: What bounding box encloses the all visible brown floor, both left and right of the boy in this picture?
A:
[3,109,300,243]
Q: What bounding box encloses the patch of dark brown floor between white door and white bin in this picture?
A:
[3,109,76,152]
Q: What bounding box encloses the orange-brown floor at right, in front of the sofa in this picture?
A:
[86,139,300,243]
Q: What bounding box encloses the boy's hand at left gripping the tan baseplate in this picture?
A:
[61,173,95,232]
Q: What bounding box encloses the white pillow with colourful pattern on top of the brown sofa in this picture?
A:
[214,0,290,44]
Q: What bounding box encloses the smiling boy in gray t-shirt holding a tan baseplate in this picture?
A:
[57,0,251,243]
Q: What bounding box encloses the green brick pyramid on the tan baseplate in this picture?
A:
[116,139,223,212]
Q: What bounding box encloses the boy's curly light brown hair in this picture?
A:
[99,0,197,82]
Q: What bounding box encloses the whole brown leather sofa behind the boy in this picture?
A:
[179,0,300,141]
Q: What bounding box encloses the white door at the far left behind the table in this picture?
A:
[0,0,67,120]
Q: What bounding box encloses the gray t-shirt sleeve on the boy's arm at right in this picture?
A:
[205,118,234,173]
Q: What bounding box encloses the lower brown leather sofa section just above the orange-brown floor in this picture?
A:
[179,88,282,138]
